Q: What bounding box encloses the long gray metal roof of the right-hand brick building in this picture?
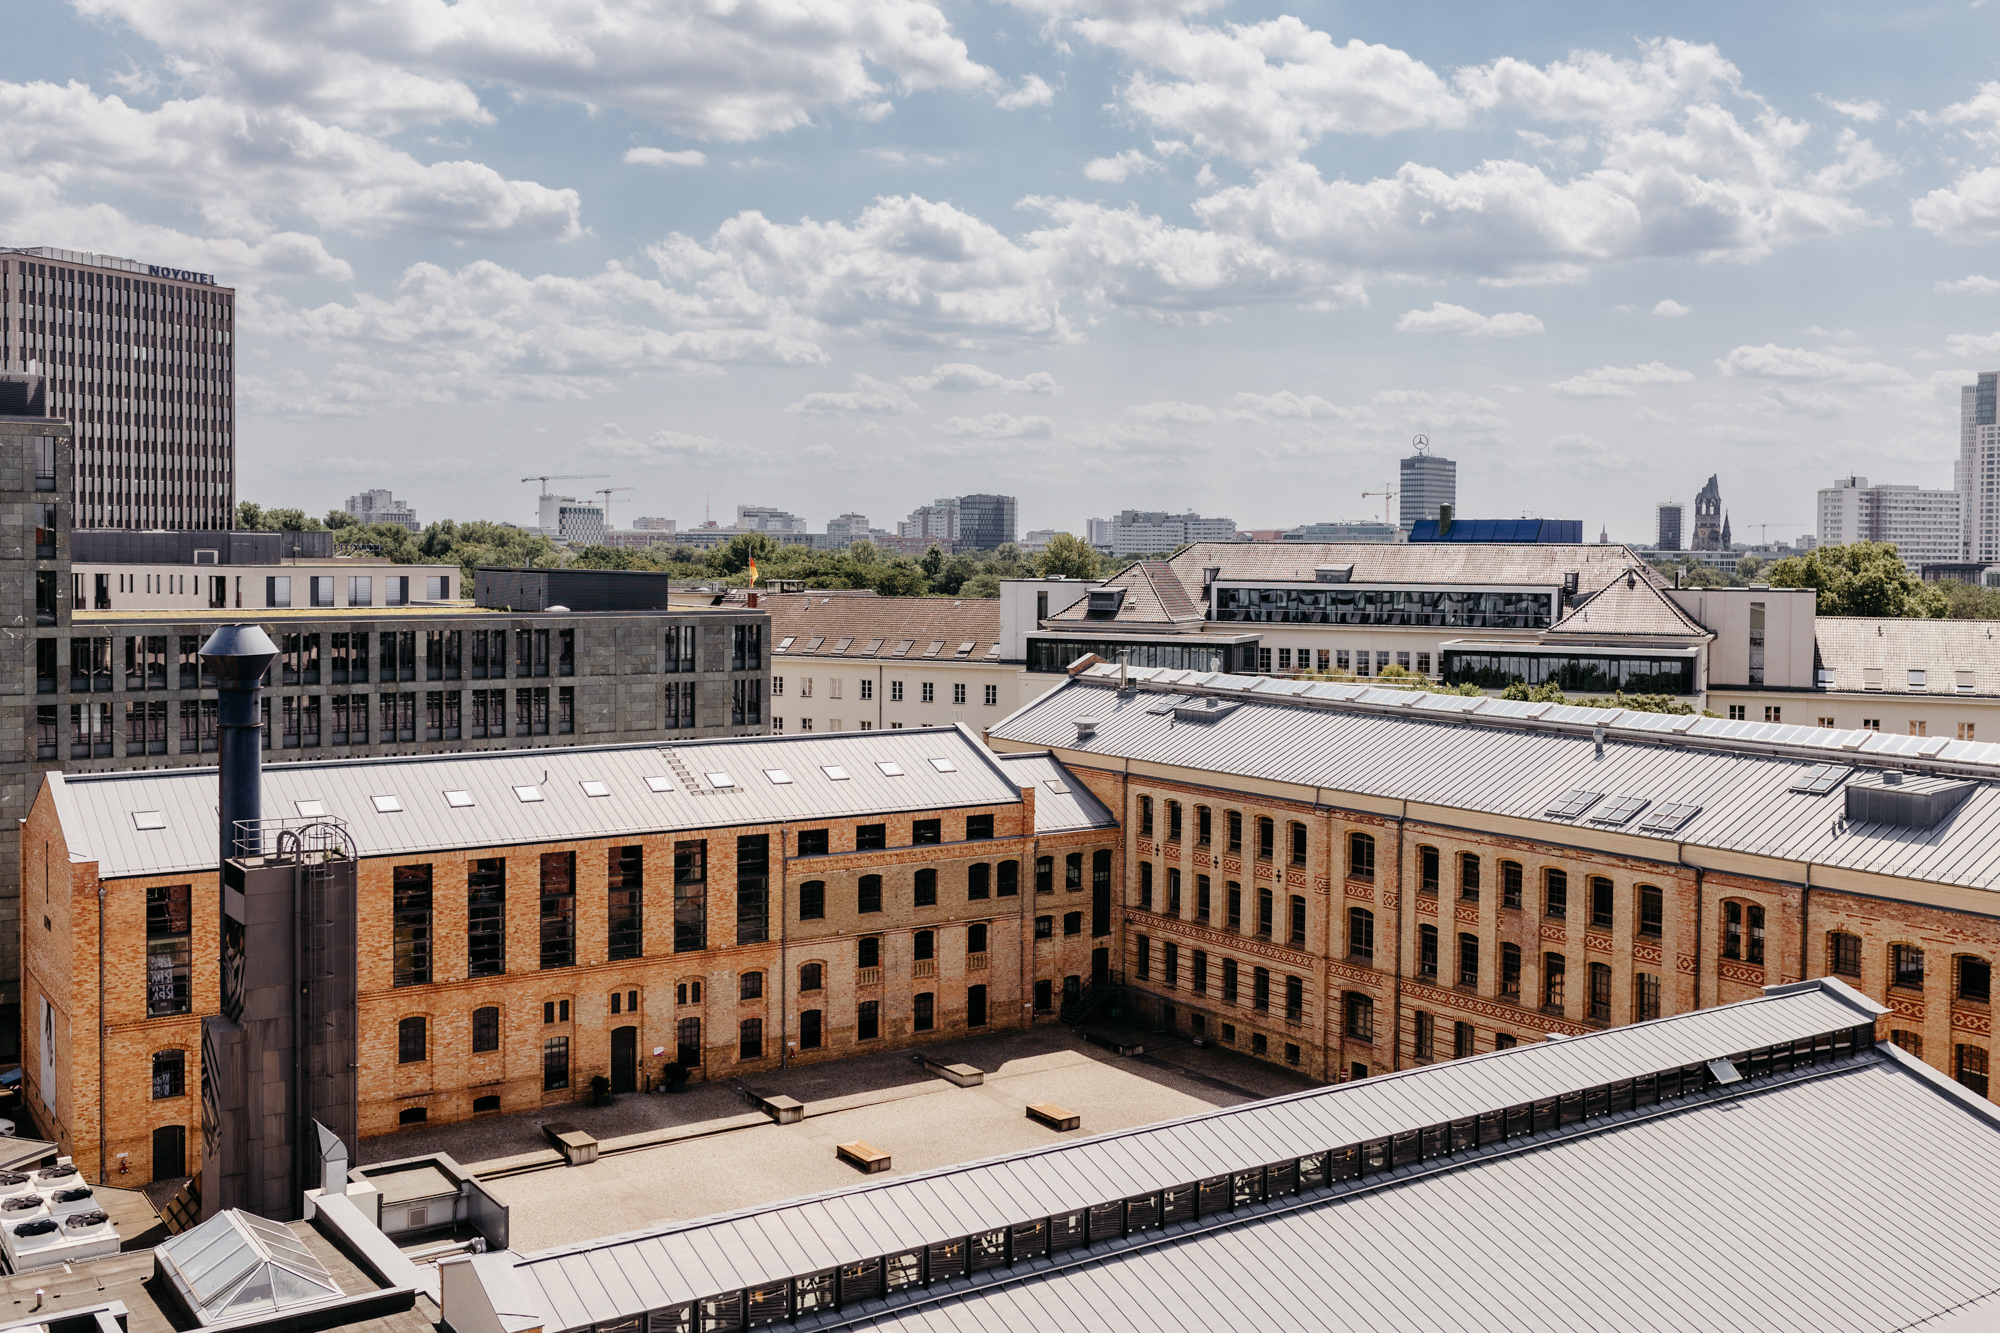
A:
[986,667,2000,889]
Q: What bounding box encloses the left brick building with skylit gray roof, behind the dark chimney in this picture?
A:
[24,729,1116,1181]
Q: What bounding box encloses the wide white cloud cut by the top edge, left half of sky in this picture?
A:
[78,0,998,142]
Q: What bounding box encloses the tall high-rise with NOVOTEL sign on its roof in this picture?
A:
[0,246,236,528]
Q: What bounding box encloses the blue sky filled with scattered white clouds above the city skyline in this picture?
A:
[11,0,2000,540]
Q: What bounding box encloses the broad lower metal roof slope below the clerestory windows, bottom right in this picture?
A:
[844,1051,2000,1333]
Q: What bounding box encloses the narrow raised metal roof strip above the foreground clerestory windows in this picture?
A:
[492,983,1884,1333]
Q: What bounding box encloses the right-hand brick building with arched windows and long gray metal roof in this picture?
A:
[988,664,2000,1093]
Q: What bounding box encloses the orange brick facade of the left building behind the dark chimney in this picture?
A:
[22,789,1120,1185]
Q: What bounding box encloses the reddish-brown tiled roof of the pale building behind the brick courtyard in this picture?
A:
[758,592,1016,662]
